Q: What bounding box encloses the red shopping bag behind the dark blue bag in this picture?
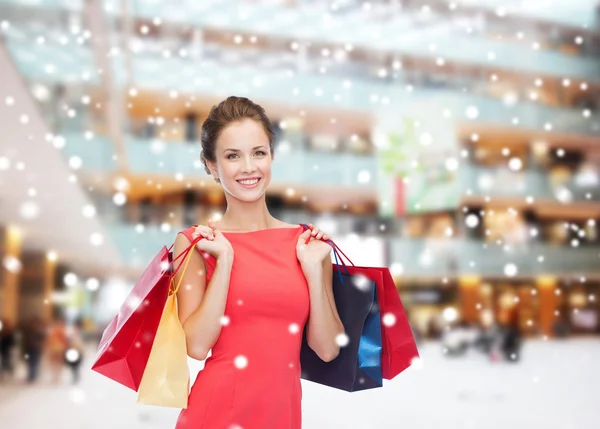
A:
[328,240,419,380]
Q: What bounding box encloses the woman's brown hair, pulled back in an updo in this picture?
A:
[200,96,275,183]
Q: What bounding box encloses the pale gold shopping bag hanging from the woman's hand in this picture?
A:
[137,244,194,408]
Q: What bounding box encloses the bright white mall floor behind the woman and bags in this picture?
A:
[0,338,600,429]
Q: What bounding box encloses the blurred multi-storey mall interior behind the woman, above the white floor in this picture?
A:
[0,0,600,358]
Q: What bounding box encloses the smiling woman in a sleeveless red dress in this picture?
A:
[174,97,343,429]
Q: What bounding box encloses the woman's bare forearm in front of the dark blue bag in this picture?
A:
[302,257,344,362]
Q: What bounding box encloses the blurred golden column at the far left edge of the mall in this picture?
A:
[0,225,23,324]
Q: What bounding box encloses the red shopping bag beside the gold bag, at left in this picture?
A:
[92,236,202,392]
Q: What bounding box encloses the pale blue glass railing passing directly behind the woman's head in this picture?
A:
[62,132,600,202]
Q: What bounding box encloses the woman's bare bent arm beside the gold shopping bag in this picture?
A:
[173,234,233,360]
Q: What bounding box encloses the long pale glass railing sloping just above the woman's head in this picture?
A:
[6,19,600,135]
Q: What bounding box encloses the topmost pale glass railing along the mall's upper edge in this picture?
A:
[0,0,600,80]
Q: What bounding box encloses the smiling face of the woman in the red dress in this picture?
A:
[207,119,272,201]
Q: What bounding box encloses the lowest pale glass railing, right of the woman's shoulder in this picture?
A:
[389,238,600,278]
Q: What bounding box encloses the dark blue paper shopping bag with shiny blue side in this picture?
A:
[300,224,382,392]
